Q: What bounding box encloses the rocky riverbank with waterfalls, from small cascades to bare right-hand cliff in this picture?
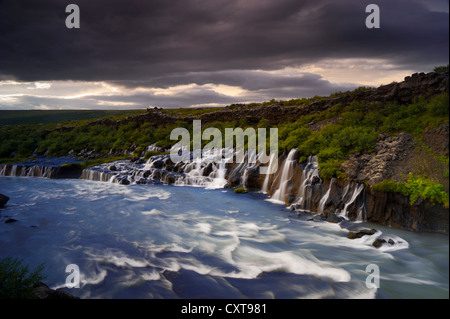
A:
[77,149,449,234]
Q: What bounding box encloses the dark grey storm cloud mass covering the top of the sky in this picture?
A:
[0,0,448,83]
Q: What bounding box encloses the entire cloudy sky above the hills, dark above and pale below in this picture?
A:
[0,0,449,110]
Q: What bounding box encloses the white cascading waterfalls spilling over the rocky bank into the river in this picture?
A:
[0,149,367,221]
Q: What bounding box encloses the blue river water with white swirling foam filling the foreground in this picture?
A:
[0,178,449,298]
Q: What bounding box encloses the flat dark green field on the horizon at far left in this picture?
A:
[0,110,146,125]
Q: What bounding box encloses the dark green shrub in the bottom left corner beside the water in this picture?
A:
[0,257,45,299]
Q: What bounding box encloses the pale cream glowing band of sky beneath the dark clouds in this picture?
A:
[0,59,431,110]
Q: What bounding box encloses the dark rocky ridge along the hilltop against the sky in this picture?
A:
[89,72,449,127]
